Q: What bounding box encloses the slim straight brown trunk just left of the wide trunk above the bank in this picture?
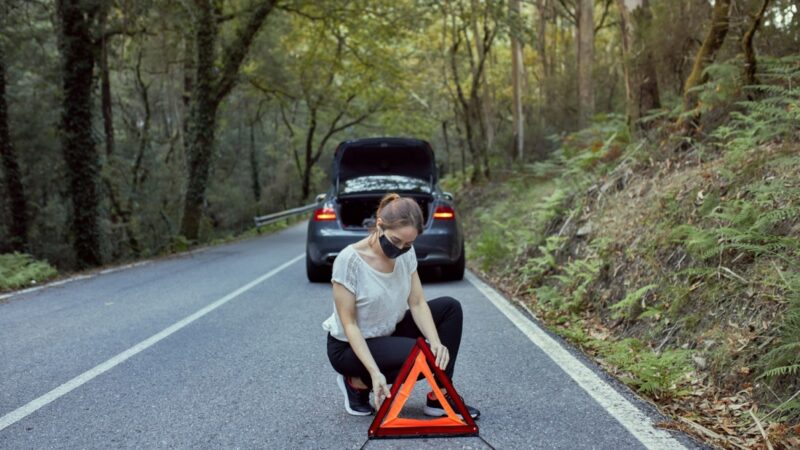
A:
[576,0,594,128]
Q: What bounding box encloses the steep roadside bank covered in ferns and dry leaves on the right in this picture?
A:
[446,59,800,448]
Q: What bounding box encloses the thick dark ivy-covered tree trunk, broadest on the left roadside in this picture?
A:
[58,0,101,268]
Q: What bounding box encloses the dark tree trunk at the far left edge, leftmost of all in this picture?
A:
[0,44,28,252]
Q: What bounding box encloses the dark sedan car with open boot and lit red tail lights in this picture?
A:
[306,138,464,282]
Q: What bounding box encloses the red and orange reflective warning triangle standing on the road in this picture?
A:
[369,338,478,439]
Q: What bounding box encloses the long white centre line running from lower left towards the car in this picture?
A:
[0,253,305,431]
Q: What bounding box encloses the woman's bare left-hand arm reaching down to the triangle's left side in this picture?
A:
[333,282,390,408]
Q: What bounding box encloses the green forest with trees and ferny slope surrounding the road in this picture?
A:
[0,0,800,448]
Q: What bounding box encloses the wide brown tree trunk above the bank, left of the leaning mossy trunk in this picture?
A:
[617,0,661,132]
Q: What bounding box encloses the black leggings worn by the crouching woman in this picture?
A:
[328,297,463,388]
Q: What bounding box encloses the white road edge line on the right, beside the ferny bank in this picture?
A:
[465,272,686,449]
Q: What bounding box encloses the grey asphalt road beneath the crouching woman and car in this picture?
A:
[0,223,696,449]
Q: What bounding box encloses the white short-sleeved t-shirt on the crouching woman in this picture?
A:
[322,244,417,342]
